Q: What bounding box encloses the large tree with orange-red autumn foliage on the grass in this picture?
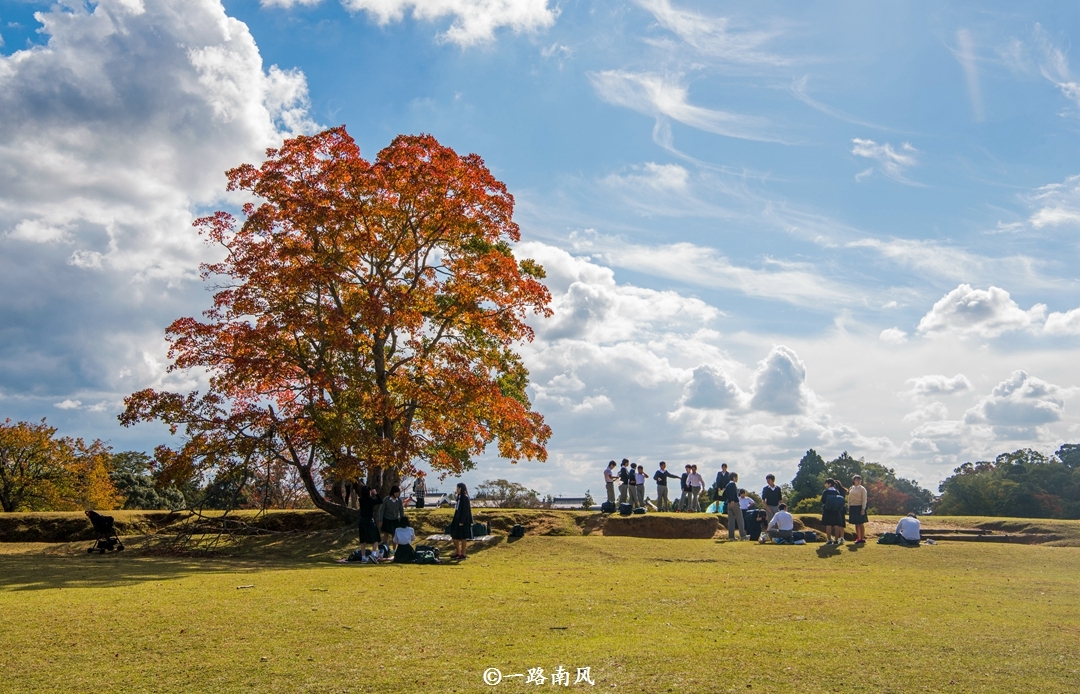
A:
[120,127,551,519]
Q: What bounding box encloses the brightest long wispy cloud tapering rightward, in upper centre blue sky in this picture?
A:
[589,70,783,142]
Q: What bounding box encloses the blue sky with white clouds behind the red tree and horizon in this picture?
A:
[0,0,1080,494]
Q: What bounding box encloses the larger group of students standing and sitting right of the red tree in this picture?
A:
[604,458,919,545]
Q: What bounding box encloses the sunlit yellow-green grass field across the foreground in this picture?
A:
[0,519,1080,694]
